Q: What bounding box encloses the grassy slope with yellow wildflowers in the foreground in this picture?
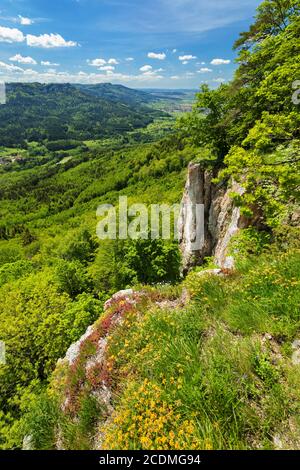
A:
[26,239,300,450]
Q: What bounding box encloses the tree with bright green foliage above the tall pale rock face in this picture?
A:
[179,0,300,226]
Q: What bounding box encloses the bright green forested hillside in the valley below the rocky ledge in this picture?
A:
[0,138,190,448]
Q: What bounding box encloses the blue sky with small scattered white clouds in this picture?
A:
[0,0,261,88]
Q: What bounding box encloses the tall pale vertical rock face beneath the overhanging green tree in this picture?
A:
[178,163,248,272]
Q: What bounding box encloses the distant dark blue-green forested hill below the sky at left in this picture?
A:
[0,83,165,147]
